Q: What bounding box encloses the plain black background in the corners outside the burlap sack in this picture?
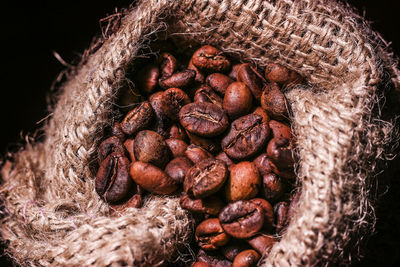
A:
[0,0,400,266]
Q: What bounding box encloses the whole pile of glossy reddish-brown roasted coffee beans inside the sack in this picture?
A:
[95,45,303,267]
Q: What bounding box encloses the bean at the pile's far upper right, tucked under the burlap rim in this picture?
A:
[265,63,303,86]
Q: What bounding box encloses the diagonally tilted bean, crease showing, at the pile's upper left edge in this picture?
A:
[121,101,154,135]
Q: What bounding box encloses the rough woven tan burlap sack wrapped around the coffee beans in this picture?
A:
[1,0,399,266]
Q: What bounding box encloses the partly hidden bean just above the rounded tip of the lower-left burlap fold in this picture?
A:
[180,195,224,216]
